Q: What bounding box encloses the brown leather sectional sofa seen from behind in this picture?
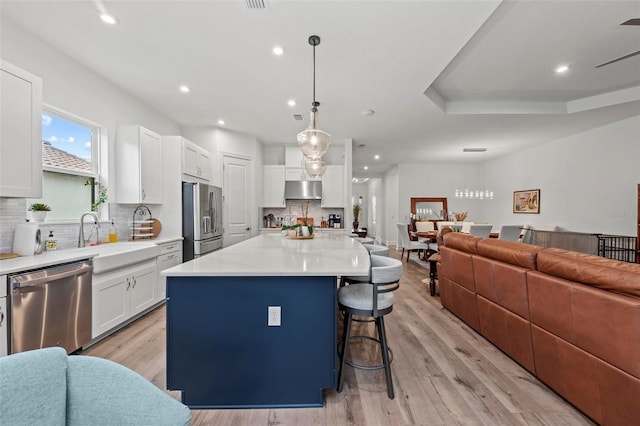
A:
[438,232,640,425]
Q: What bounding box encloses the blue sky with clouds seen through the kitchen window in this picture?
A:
[42,112,91,161]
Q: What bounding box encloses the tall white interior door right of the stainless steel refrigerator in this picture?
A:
[222,155,252,247]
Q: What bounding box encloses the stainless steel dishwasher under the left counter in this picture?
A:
[8,260,93,353]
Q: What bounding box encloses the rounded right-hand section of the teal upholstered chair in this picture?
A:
[67,356,191,425]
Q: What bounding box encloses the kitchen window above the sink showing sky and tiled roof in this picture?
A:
[27,106,102,221]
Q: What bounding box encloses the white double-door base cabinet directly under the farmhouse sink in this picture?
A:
[91,259,157,338]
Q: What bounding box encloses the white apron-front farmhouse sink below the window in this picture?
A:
[86,242,159,274]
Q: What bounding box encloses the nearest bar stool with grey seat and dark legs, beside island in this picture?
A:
[338,255,402,399]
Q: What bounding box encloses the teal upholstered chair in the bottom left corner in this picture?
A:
[0,348,191,426]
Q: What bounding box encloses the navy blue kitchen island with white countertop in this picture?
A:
[163,233,369,409]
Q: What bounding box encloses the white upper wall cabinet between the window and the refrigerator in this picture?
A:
[115,126,162,204]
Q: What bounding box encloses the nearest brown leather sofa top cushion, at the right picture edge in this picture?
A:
[537,248,640,297]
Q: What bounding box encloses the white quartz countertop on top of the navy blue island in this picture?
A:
[163,233,369,277]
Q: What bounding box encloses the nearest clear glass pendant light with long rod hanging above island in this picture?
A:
[298,35,331,163]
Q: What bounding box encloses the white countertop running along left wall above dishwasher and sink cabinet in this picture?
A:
[0,237,182,274]
